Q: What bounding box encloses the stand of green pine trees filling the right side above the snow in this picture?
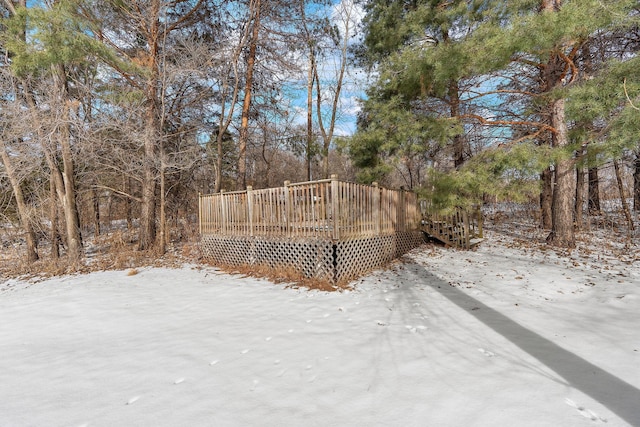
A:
[349,0,640,247]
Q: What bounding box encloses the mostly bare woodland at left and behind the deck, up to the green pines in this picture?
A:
[0,0,355,264]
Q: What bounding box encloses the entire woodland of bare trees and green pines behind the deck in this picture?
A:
[0,0,640,269]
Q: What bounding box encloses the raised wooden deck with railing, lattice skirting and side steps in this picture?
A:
[199,177,482,284]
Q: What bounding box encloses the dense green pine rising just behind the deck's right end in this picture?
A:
[350,1,480,183]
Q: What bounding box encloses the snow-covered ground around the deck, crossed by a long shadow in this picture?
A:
[0,234,640,427]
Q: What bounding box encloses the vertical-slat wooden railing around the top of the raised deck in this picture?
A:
[199,176,421,241]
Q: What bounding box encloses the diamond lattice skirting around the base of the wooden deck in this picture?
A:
[201,231,424,284]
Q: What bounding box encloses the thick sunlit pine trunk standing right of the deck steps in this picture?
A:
[547,99,576,248]
